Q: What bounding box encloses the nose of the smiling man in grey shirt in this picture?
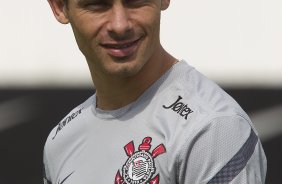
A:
[107,4,132,40]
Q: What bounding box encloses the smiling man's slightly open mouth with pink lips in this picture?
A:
[100,37,142,58]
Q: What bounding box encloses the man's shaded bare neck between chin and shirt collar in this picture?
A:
[91,50,176,110]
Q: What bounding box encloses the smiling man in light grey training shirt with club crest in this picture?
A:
[44,0,266,184]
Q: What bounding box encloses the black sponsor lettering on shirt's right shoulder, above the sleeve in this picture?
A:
[163,96,193,119]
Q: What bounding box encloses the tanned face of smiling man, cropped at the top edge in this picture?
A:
[62,0,169,77]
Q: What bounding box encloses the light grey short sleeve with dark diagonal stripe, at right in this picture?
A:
[178,115,266,184]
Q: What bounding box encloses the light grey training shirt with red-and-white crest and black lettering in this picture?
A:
[44,61,266,184]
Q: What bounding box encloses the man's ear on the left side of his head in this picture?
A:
[48,0,69,24]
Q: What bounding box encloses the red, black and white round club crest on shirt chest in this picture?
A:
[115,137,166,184]
